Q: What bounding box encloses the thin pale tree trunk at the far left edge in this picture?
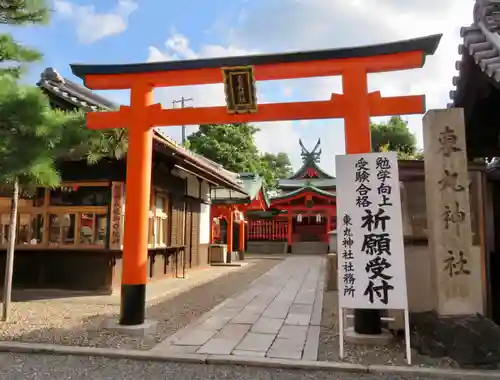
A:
[2,177,19,322]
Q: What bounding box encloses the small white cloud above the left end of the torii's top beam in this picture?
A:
[54,0,138,44]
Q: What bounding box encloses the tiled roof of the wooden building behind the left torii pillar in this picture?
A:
[37,67,245,191]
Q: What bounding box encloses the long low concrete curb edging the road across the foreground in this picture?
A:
[0,341,500,380]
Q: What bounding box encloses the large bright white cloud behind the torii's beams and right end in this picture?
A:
[149,0,473,172]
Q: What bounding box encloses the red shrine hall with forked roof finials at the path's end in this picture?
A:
[247,140,336,254]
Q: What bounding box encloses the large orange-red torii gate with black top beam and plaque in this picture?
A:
[71,35,441,325]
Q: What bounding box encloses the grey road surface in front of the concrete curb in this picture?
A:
[0,354,462,380]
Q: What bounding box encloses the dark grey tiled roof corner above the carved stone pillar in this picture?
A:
[448,0,500,107]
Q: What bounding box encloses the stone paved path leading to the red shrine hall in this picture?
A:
[153,255,325,360]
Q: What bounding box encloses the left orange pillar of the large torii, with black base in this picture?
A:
[120,85,153,325]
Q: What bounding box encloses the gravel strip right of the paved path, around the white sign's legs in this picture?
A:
[318,291,458,368]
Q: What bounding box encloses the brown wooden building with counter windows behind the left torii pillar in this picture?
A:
[0,68,244,292]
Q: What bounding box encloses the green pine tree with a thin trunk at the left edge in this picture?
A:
[0,0,51,321]
